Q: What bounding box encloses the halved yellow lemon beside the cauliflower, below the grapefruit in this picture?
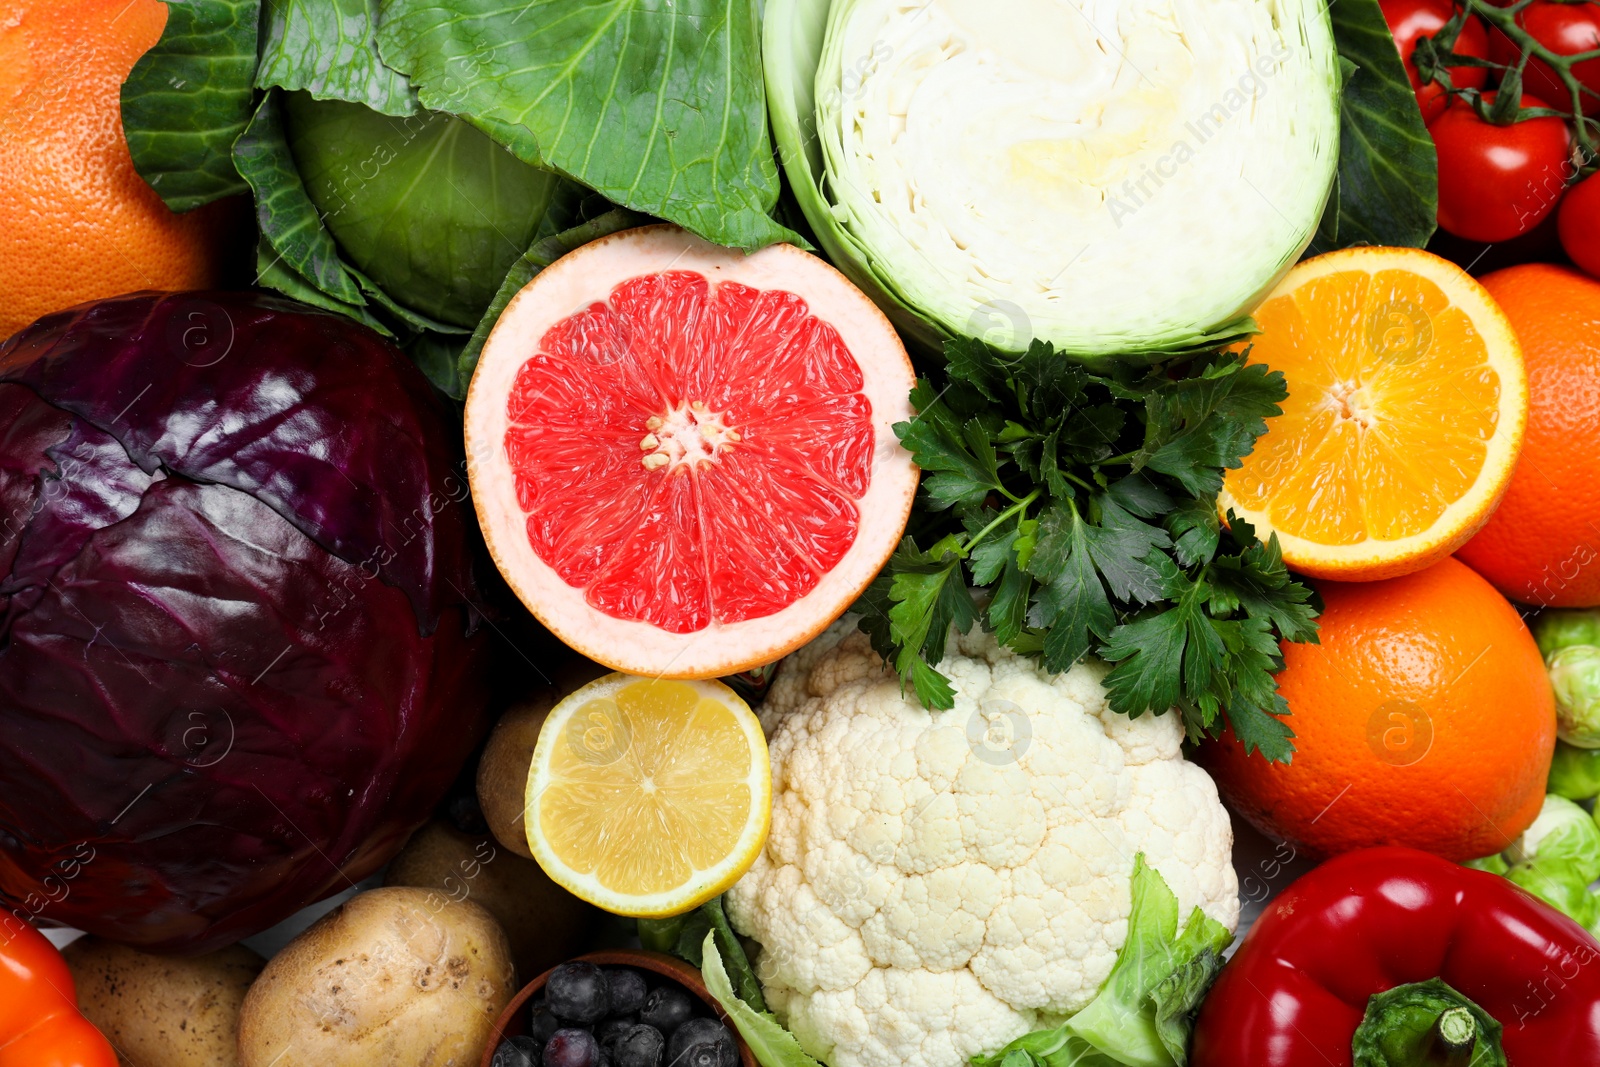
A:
[526,673,773,917]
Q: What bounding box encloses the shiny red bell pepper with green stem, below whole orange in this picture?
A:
[1190,848,1600,1067]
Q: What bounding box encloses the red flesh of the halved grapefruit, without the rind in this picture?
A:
[504,270,875,633]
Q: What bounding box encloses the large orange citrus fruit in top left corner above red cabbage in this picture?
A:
[0,0,224,341]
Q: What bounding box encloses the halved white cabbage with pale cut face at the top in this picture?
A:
[765,0,1339,358]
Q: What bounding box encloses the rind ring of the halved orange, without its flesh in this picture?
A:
[1218,246,1528,581]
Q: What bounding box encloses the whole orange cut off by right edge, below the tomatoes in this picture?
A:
[1456,264,1600,608]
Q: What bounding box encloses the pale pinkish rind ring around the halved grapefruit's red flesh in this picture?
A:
[466,226,918,678]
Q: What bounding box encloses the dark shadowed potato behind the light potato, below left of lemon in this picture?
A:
[384,819,600,982]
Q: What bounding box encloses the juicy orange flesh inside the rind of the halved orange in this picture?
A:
[1227,270,1501,545]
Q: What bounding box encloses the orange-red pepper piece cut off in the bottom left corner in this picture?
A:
[0,915,117,1067]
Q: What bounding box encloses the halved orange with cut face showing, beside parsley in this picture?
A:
[1218,248,1528,581]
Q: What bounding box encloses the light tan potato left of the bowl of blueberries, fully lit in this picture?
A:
[238,886,517,1067]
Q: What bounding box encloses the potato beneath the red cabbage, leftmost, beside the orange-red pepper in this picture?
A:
[62,937,264,1067]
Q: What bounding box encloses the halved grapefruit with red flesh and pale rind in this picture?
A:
[466,226,917,678]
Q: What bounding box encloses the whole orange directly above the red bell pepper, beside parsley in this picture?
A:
[1198,558,1555,861]
